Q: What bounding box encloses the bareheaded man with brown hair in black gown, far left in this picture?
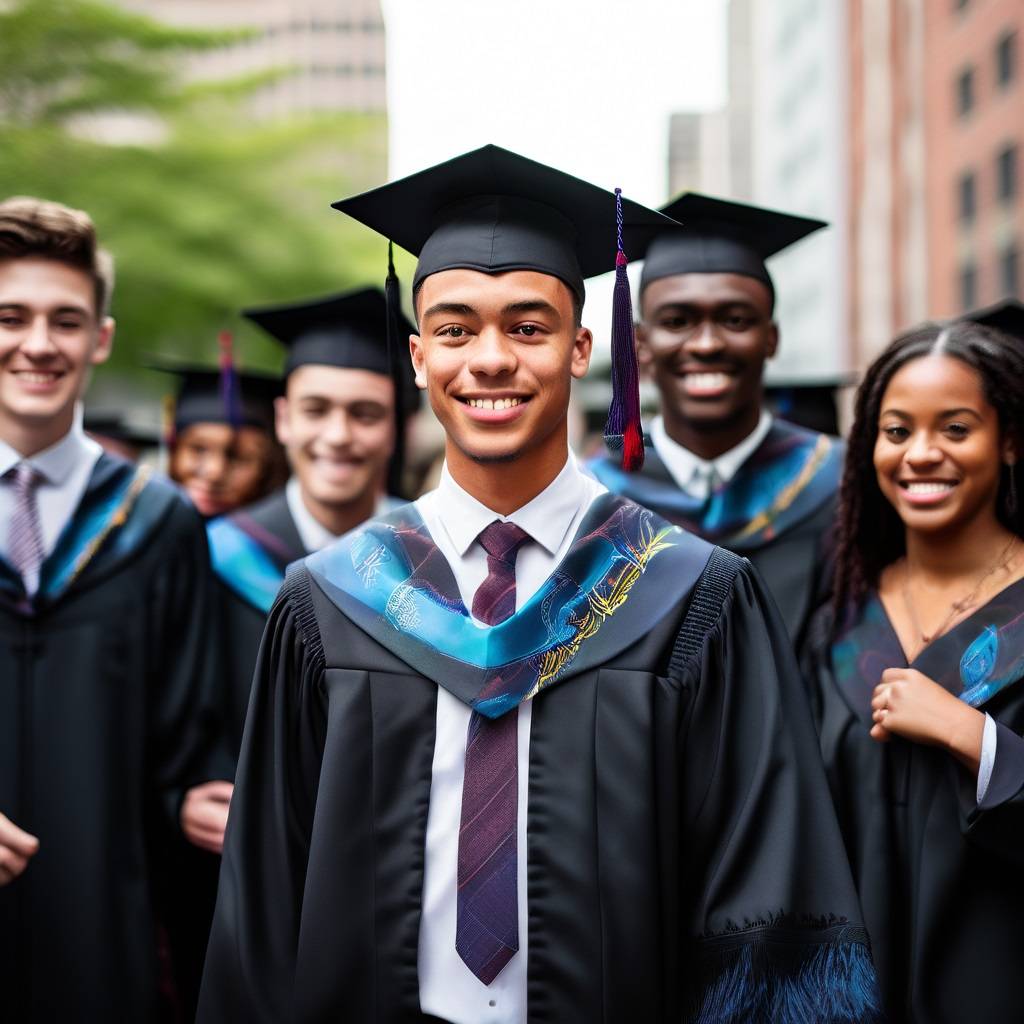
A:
[0,199,222,1021]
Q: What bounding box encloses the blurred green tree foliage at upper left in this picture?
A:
[0,0,386,373]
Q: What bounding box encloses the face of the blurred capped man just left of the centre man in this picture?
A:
[274,365,394,508]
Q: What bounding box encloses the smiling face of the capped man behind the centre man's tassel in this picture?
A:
[637,273,778,431]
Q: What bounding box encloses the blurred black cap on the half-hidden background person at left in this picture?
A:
[146,358,281,433]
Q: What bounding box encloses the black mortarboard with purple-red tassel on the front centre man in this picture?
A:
[334,145,673,468]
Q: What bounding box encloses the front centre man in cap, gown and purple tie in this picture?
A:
[200,146,873,1024]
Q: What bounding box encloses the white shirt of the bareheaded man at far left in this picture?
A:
[0,411,103,594]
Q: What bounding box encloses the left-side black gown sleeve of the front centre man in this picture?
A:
[197,566,325,1024]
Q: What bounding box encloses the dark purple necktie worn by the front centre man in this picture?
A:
[455,522,529,985]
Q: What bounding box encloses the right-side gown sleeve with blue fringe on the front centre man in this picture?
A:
[681,563,881,1024]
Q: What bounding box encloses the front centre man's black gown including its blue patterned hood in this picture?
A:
[199,496,873,1024]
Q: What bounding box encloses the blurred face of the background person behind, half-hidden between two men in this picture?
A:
[170,423,272,518]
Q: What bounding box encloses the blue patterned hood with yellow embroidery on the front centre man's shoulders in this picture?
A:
[306,495,712,718]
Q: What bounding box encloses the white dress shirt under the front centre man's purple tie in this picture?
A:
[416,454,605,1024]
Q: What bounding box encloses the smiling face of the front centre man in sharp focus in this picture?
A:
[410,269,593,463]
